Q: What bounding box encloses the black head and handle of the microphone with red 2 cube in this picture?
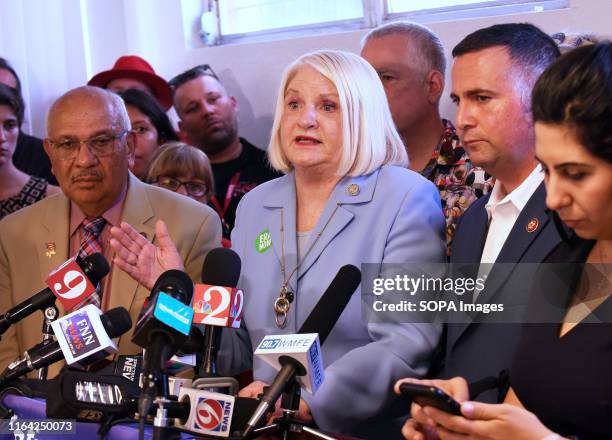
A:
[202,248,242,377]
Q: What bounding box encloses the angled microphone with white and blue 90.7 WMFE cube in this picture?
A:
[243,264,361,438]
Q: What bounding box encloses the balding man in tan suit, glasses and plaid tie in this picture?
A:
[0,87,221,377]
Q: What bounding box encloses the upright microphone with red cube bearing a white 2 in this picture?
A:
[193,248,244,377]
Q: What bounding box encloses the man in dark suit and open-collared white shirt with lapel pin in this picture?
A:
[402,23,561,430]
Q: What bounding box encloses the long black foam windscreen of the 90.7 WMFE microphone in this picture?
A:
[298,264,361,345]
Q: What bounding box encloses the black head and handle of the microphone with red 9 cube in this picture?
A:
[0,253,110,335]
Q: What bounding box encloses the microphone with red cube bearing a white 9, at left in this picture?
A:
[0,253,110,335]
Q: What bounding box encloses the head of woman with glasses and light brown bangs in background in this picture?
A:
[146,142,214,203]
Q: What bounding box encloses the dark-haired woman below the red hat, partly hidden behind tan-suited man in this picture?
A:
[119,89,179,181]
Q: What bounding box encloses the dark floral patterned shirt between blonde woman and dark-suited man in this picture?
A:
[421,119,494,255]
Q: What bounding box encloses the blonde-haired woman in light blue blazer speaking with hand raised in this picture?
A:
[111,50,445,439]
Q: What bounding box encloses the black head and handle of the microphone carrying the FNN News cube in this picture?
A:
[0,307,132,386]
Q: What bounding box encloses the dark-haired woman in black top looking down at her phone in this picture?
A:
[396,42,612,440]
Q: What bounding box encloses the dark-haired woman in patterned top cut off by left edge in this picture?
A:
[0,84,59,219]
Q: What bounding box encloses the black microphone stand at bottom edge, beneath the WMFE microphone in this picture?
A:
[243,377,335,440]
